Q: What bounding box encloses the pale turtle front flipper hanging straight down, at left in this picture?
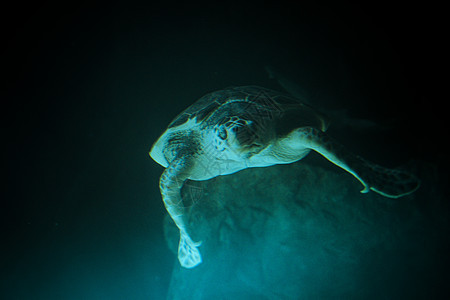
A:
[159,159,202,268]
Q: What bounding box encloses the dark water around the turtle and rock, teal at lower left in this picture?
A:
[0,2,449,299]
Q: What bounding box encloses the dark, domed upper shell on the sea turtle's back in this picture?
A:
[168,86,327,135]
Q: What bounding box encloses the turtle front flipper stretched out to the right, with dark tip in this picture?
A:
[286,127,420,198]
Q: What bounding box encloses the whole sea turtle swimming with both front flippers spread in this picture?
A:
[150,86,419,268]
